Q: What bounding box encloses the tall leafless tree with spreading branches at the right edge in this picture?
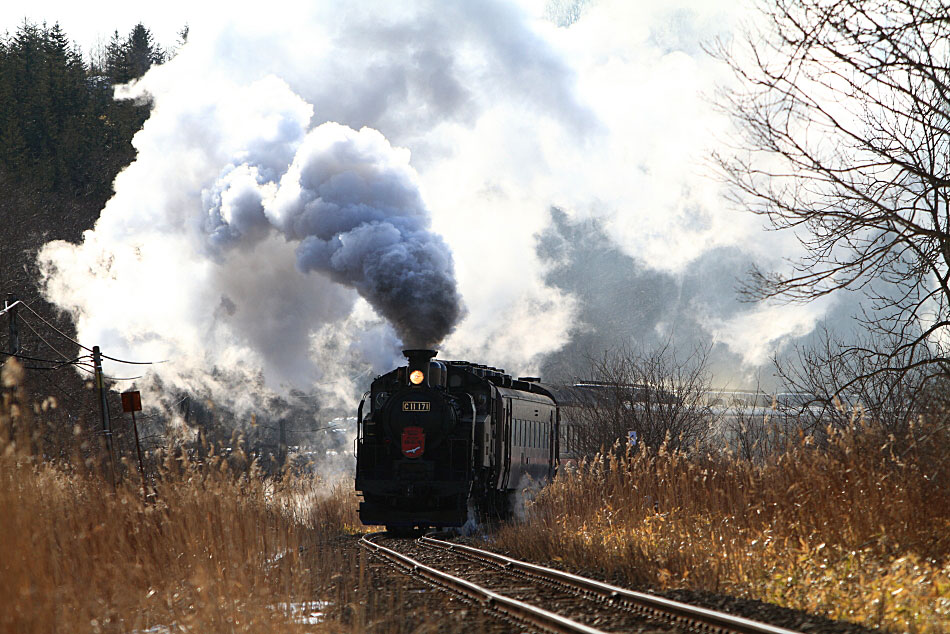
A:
[711,0,950,388]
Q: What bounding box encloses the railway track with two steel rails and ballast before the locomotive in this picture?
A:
[361,533,797,634]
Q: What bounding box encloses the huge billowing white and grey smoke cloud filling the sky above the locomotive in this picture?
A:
[40,0,832,405]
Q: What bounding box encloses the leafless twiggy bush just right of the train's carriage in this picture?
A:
[566,342,712,455]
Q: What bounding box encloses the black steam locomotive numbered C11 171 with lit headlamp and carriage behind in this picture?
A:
[356,350,569,532]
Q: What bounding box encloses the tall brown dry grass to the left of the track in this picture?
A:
[0,364,393,633]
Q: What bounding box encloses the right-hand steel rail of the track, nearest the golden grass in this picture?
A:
[419,537,800,634]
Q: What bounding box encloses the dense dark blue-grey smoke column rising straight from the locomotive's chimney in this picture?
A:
[207,123,463,347]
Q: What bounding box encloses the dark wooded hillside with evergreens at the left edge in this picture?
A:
[0,22,166,451]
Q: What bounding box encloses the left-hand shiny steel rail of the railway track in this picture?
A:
[360,533,606,634]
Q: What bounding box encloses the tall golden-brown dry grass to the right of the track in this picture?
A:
[498,418,950,633]
